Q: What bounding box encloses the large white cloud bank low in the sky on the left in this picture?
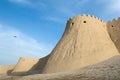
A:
[0,25,50,65]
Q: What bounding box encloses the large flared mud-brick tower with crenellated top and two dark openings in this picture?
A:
[43,15,119,73]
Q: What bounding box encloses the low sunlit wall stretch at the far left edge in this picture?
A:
[0,65,15,74]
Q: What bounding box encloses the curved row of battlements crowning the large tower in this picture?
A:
[68,14,106,24]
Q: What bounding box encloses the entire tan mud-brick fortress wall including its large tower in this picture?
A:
[0,15,120,74]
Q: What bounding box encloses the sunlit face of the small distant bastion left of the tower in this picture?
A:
[12,57,39,73]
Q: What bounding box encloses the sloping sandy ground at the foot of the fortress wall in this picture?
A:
[0,56,120,80]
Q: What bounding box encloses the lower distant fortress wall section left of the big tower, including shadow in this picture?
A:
[0,55,49,76]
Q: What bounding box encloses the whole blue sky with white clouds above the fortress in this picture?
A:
[0,0,120,65]
